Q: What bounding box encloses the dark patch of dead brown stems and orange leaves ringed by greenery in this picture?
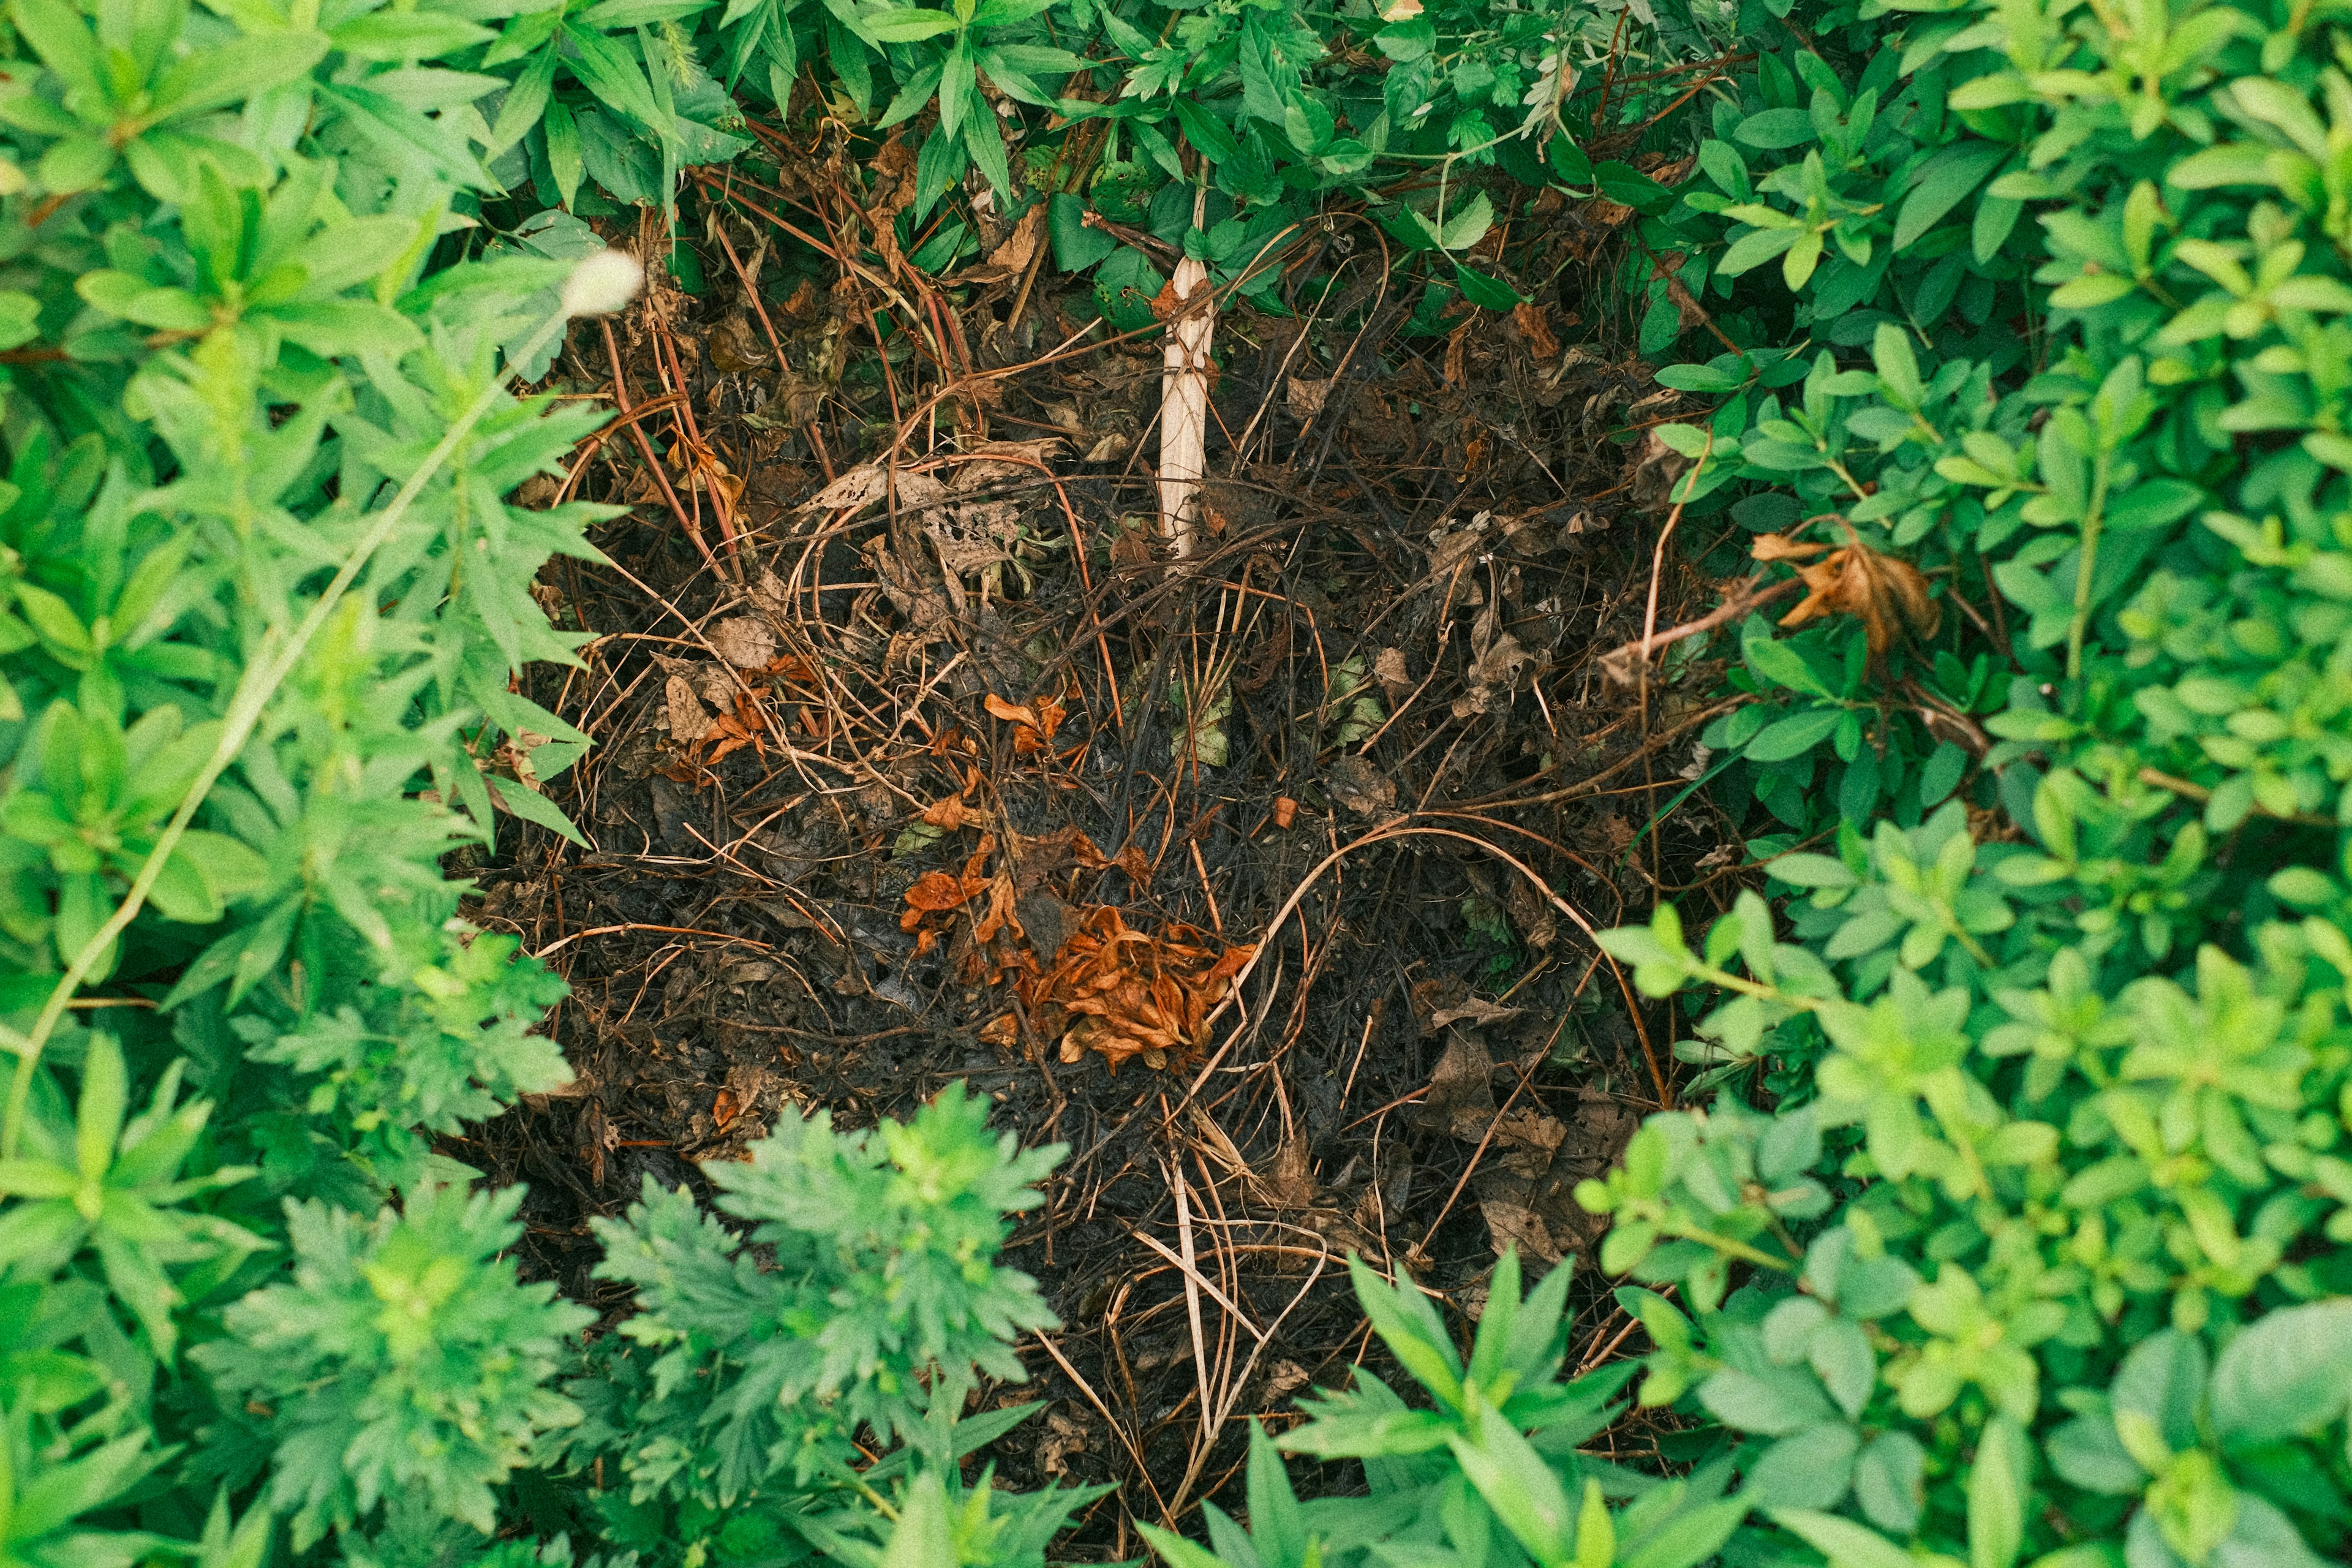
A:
[454,160,1731,1561]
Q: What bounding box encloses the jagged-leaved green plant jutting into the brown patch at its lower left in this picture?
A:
[569,1086,1094,1568]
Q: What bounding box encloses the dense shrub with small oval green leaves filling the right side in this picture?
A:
[1543,0,2352,1568]
